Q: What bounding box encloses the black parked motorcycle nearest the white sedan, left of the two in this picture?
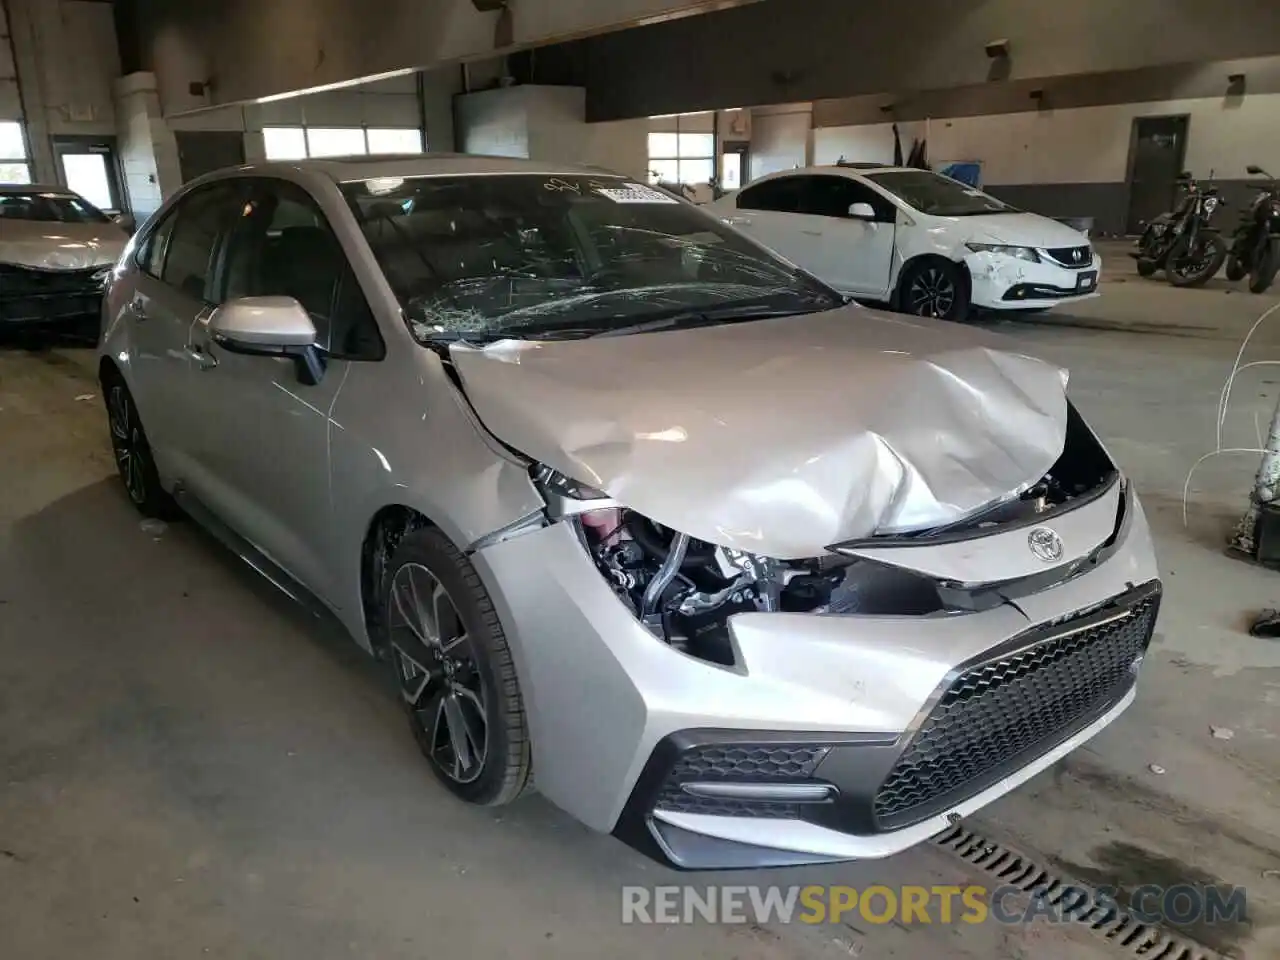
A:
[1130,173,1226,287]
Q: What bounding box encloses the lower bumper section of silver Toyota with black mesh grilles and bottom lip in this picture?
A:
[614,584,1160,869]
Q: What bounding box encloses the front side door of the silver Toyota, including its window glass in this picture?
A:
[189,178,383,598]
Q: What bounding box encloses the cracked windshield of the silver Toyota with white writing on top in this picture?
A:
[343,174,842,342]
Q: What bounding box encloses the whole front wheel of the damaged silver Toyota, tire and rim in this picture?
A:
[381,527,532,806]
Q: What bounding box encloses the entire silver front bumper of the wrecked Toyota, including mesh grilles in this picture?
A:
[472,483,1158,868]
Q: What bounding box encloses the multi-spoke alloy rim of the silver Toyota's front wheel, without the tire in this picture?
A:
[389,563,489,783]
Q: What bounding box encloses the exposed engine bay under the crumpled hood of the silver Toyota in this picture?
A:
[559,407,1119,664]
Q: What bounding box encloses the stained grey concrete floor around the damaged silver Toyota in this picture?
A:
[0,256,1280,960]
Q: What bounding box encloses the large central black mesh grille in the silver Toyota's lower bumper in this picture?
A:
[874,594,1158,828]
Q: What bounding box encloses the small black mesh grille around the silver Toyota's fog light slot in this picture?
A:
[655,744,829,818]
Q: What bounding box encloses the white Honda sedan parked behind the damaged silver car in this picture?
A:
[710,165,1102,320]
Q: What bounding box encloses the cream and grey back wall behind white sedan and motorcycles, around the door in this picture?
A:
[814,93,1280,232]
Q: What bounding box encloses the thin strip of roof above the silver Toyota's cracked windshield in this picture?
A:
[233,154,632,183]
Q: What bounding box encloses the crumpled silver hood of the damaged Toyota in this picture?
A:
[451,306,1066,559]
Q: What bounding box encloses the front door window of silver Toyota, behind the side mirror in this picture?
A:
[223,179,384,360]
